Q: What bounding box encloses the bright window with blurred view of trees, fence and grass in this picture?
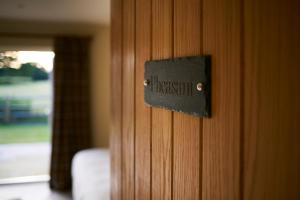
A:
[0,51,54,183]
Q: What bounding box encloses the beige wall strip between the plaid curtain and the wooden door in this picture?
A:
[91,27,110,147]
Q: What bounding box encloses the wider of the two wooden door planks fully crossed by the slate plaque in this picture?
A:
[173,0,202,200]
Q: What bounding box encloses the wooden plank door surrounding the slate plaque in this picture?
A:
[111,0,300,200]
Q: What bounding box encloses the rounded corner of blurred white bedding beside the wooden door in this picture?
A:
[72,149,110,200]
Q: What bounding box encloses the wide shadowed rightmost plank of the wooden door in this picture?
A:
[244,0,300,200]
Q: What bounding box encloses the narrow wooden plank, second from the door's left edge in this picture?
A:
[122,0,135,200]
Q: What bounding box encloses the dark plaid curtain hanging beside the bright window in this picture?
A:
[50,37,91,190]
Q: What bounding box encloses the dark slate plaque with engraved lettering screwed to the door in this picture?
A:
[144,56,211,117]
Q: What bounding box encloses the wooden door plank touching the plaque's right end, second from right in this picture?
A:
[202,0,241,200]
